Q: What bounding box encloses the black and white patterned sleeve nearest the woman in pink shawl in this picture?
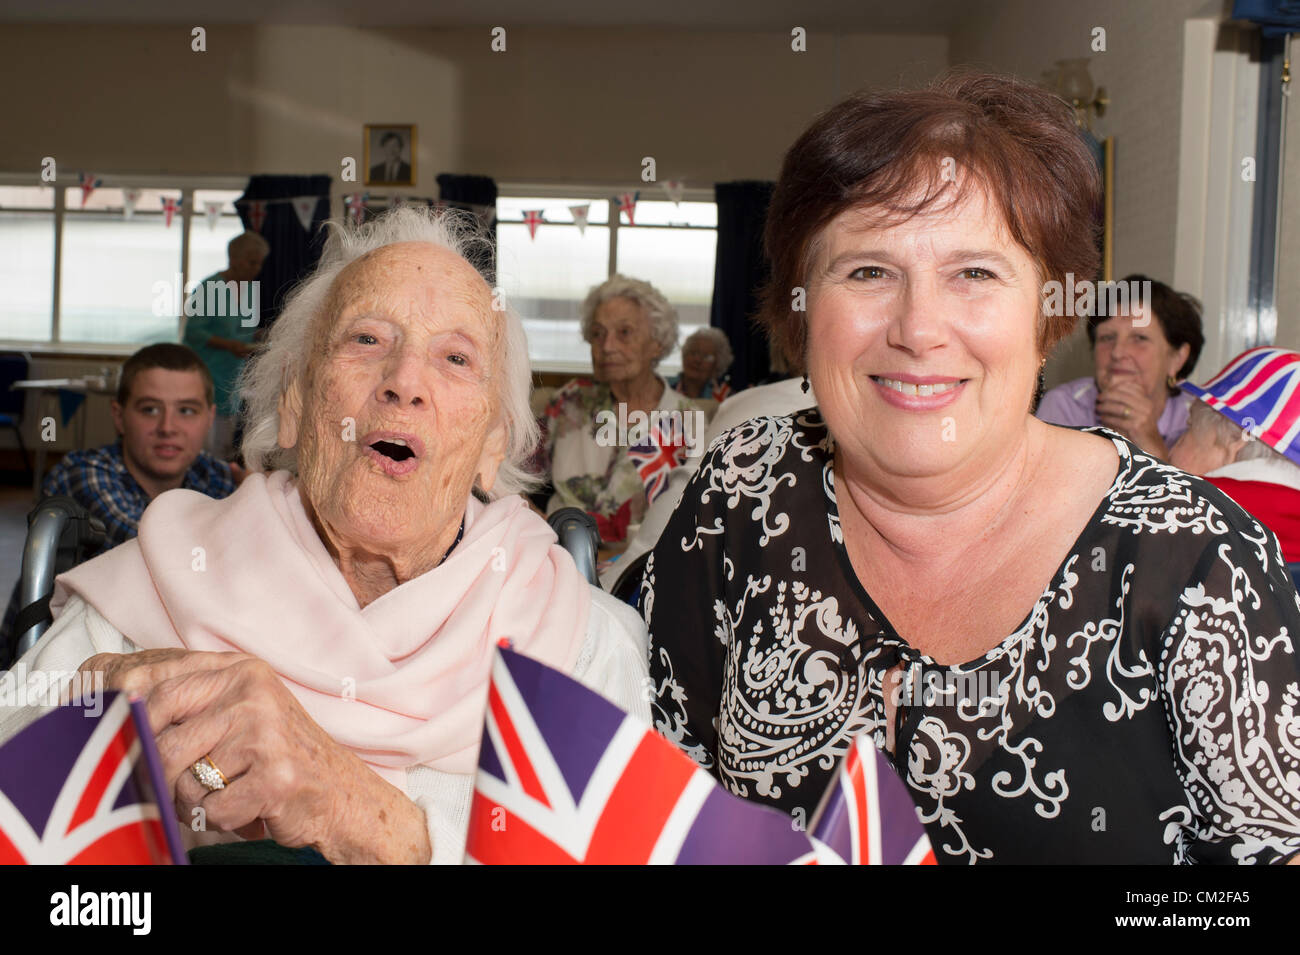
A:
[641,447,731,773]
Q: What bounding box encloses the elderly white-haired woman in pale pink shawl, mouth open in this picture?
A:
[0,208,647,863]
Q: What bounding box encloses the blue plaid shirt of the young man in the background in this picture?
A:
[0,444,235,659]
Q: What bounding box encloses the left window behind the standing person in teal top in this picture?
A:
[0,174,243,347]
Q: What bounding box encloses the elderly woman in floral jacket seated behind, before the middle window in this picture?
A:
[538,275,694,541]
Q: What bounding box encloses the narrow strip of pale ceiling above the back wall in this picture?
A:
[0,0,977,34]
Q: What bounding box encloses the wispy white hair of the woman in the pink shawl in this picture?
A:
[239,205,540,500]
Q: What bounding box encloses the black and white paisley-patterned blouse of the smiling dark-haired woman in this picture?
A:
[641,409,1300,863]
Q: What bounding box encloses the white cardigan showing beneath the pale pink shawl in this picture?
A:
[0,587,650,864]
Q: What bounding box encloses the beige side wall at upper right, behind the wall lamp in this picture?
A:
[949,0,1213,386]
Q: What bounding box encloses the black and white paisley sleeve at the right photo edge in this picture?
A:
[1158,509,1300,864]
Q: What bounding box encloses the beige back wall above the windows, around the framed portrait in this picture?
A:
[0,26,948,195]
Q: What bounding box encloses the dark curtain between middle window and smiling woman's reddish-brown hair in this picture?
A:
[710,182,772,391]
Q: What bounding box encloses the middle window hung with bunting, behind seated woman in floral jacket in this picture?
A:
[497,188,718,374]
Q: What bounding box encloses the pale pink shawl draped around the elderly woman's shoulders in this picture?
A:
[52,472,592,787]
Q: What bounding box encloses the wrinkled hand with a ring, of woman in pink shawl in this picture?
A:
[87,650,432,863]
